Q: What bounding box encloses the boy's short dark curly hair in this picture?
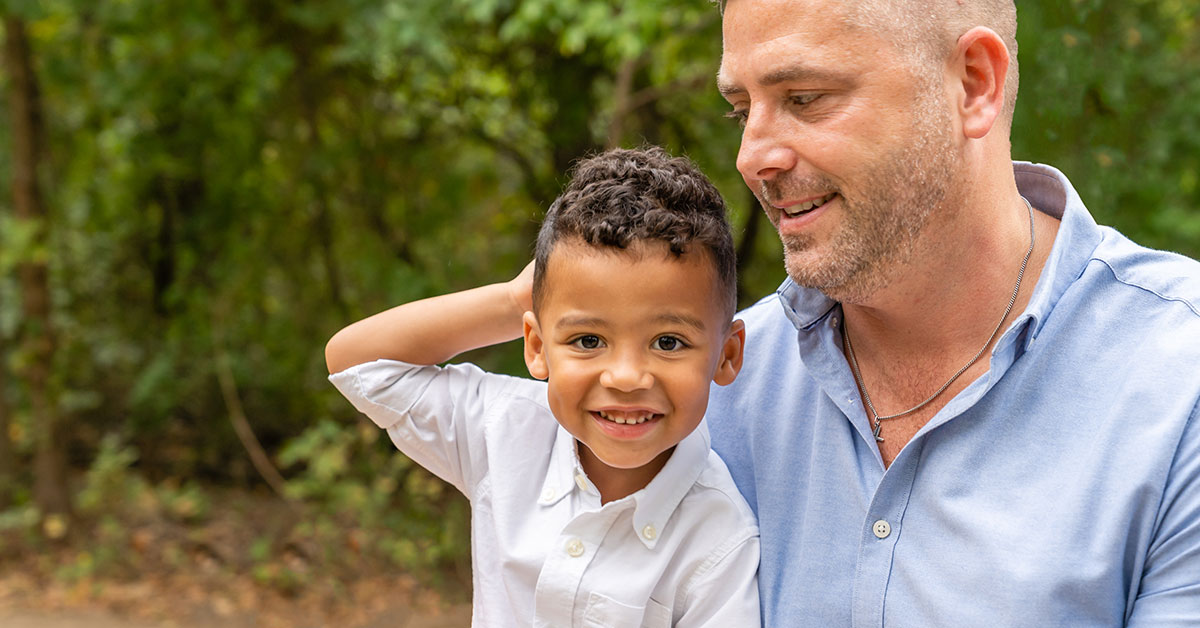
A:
[533,146,737,319]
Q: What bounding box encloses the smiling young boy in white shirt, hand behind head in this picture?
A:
[325,149,760,628]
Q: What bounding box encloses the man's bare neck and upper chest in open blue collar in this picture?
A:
[842,186,1058,465]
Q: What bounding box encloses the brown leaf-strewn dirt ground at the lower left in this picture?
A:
[0,490,470,628]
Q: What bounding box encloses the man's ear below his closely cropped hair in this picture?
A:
[954,26,1008,139]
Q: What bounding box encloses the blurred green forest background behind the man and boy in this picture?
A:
[0,0,1200,624]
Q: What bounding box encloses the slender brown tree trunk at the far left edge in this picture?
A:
[4,16,71,527]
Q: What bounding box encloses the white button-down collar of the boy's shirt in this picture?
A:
[538,421,710,549]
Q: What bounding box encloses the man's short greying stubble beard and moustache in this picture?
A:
[758,90,956,303]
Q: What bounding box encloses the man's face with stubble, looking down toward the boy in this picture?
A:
[718,0,959,303]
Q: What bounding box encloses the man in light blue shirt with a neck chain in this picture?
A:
[709,0,1200,627]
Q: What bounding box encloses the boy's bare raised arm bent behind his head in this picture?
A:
[325,262,533,373]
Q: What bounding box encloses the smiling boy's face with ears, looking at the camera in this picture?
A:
[524,240,745,482]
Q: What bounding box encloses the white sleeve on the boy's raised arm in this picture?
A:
[329,360,521,498]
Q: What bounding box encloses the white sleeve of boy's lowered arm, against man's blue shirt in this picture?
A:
[676,528,762,628]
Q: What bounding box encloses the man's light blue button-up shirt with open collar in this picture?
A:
[708,163,1200,628]
